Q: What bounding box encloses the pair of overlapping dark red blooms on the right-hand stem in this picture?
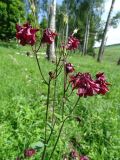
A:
[70,72,109,97]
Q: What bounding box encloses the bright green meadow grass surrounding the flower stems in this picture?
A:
[0,44,120,160]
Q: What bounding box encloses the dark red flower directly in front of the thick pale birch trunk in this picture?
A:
[42,28,57,44]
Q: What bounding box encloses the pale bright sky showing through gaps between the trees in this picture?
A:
[57,0,120,47]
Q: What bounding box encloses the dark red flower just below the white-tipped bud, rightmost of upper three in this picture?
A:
[65,36,80,50]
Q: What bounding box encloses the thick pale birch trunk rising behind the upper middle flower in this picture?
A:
[46,0,56,61]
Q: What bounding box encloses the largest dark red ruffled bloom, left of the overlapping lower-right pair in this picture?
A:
[70,73,99,97]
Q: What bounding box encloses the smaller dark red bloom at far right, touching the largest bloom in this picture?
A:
[96,73,110,95]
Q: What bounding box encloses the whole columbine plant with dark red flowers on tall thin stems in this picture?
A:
[16,23,109,160]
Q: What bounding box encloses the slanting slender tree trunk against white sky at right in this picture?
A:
[97,0,115,62]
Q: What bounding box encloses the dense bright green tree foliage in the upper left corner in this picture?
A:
[0,0,25,40]
